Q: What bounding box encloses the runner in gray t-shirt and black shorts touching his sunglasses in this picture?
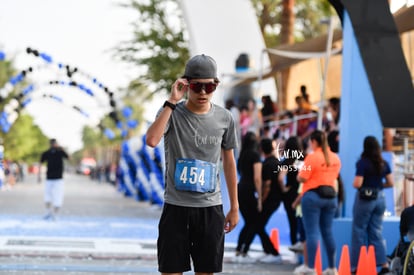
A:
[146,54,239,275]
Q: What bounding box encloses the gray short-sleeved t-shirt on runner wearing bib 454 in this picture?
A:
[164,102,237,207]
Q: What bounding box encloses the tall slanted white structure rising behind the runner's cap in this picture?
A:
[180,0,276,104]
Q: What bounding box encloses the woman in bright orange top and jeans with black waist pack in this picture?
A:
[298,130,341,275]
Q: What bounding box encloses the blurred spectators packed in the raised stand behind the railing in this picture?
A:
[226,85,340,155]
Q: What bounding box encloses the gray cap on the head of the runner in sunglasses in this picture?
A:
[183,54,217,79]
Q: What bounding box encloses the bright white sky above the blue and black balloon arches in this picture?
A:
[0,0,406,152]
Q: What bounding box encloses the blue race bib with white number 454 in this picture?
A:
[174,159,216,193]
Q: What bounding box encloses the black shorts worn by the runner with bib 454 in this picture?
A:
[157,204,224,273]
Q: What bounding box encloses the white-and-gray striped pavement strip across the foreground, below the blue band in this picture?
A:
[0,237,294,275]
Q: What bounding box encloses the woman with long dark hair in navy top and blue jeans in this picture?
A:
[351,136,394,274]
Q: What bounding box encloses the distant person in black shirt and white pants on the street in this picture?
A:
[38,138,69,220]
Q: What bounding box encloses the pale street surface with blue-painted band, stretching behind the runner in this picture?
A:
[0,175,295,275]
